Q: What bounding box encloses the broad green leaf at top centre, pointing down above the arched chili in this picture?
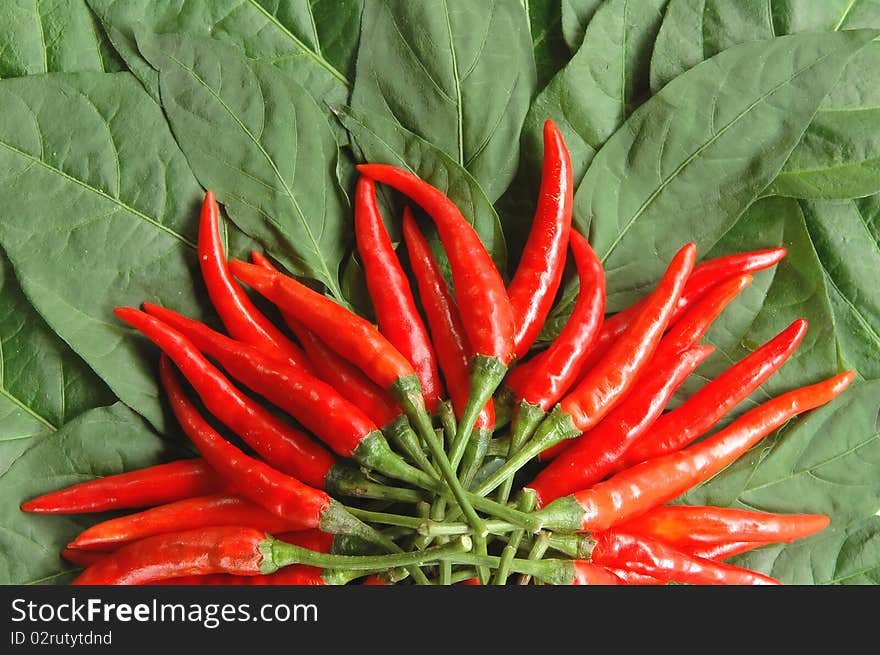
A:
[350,0,535,202]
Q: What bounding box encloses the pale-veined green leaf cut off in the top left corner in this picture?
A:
[0,0,122,79]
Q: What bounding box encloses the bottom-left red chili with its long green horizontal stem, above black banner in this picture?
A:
[73,526,471,585]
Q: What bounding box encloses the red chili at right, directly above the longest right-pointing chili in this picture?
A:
[621,319,807,468]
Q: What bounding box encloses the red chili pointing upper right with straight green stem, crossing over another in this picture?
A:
[464,243,696,495]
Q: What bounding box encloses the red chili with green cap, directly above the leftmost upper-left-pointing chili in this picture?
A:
[144,303,434,490]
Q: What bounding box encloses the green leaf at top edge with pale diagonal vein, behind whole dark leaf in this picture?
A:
[88,0,363,102]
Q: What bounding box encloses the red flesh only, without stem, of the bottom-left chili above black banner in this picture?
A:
[73,526,266,585]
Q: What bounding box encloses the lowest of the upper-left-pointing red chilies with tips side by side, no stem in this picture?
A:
[114,307,336,488]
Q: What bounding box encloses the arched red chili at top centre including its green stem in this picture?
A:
[358,164,515,492]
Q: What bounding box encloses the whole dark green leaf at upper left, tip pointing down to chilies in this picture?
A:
[138,34,351,300]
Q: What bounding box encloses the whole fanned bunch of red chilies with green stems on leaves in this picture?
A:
[22,121,853,585]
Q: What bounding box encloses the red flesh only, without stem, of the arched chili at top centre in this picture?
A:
[357,164,514,366]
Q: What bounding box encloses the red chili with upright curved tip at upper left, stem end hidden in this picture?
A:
[198,191,309,370]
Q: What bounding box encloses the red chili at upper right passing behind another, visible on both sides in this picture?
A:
[581,248,786,376]
